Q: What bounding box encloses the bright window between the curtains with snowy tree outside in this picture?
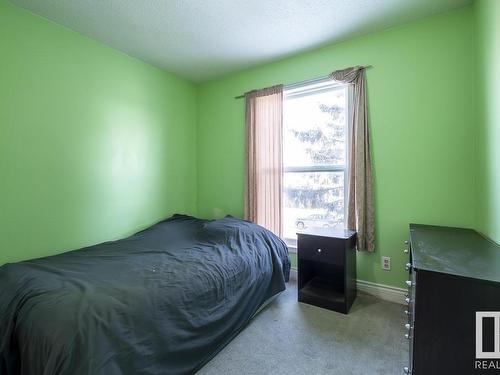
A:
[283,80,349,247]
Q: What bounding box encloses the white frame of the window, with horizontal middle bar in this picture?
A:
[283,77,353,248]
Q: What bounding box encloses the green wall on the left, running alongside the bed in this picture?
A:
[0,0,196,264]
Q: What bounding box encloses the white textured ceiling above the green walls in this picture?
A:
[11,0,471,82]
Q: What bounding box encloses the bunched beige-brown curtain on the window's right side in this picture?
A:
[330,66,375,251]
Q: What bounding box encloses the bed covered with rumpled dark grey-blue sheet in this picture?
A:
[0,215,290,375]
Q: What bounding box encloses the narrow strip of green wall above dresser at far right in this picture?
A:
[474,0,500,243]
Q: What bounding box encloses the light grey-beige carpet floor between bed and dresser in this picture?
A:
[197,280,408,375]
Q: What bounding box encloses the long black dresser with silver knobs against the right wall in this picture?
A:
[403,224,500,375]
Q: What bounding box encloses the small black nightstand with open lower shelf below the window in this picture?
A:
[297,228,356,314]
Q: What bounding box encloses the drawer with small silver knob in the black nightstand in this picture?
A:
[297,235,345,265]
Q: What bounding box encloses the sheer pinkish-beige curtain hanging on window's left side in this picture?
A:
[245,85,283,236]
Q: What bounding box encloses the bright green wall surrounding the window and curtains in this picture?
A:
[197,7,476,287]
